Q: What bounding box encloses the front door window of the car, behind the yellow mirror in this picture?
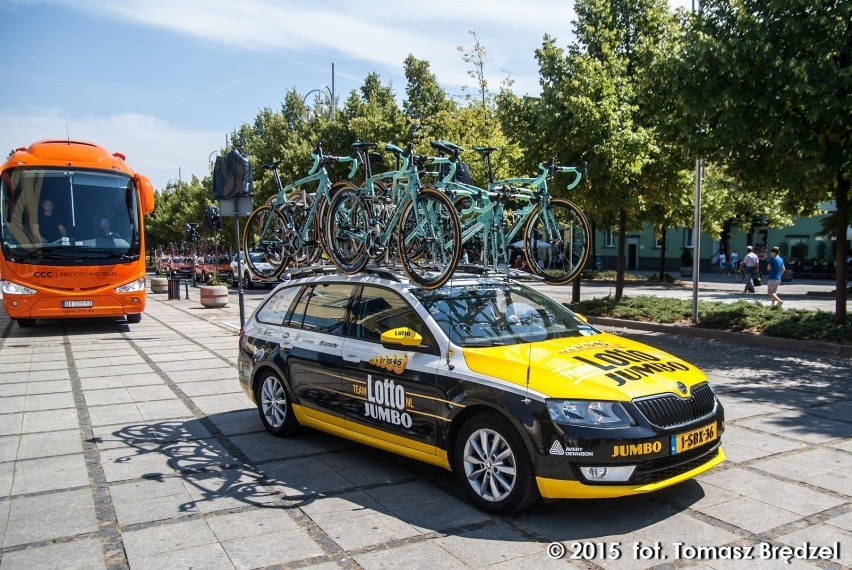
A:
[350,285,435,348]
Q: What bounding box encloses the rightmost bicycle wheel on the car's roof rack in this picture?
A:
[524,198,591,285]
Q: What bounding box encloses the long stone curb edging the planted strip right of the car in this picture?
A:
[586,316,852,358]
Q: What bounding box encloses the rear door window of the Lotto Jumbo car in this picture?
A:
[290,283,353,335]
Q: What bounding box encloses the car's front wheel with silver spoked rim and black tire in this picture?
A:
[453,412,541,515]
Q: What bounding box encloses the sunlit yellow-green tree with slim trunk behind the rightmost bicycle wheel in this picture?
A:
[536,0,687,299]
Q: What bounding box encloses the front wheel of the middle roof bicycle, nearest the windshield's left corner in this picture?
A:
[397,188,461,289]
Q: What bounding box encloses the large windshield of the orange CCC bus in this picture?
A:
[0,167,141,265]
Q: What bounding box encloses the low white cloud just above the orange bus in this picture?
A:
[0,109,225,190]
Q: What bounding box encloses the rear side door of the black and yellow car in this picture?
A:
[280,283,354,426]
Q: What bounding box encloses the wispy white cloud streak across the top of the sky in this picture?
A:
[74,0,574,91]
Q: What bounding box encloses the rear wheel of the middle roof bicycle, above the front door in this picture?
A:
[325,189,370,275]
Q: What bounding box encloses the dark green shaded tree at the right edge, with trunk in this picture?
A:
[657,0,852,323]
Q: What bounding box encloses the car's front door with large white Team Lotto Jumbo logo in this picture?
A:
[342,285,444,455]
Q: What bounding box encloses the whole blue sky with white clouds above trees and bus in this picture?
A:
[0,0,690,189]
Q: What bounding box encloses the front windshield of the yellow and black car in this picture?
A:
[413,282,599,346]
